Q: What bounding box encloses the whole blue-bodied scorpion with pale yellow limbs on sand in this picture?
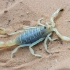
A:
[0,8,70,58]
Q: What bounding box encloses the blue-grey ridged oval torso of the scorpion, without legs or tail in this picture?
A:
[16,26,49,45]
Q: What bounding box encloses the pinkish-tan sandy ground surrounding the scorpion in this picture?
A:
[0,0,70,70]
